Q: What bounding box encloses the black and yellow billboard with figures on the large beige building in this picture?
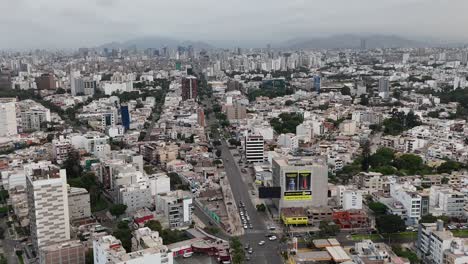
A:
[283,171,312,200]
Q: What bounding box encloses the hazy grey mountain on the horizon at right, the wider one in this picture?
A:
[281,34,429,49]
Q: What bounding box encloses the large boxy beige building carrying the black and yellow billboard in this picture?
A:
[272,157,328,211]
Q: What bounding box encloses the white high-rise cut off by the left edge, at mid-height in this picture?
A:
[0,98,18,137]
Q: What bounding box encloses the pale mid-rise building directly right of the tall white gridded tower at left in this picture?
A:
[68,187,91,221]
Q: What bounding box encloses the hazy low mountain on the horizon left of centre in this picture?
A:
[98,37,213,49]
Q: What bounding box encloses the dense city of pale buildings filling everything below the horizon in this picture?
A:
[0,23,468,264]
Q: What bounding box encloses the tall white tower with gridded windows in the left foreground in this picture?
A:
[24,161,70,251]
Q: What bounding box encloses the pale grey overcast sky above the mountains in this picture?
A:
[0,0,468,49]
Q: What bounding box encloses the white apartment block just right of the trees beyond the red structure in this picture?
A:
[390,183,422,225]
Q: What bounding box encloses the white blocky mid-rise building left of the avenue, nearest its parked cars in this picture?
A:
[156,190,193,228]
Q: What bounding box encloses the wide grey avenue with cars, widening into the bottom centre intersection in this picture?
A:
[219,140,283,264]
